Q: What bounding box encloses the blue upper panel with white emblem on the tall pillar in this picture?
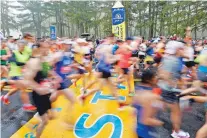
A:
[112,8,125,25]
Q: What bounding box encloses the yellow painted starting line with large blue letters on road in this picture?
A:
[11,75,137,138]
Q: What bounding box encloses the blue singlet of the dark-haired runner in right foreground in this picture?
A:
[133,86,157,138]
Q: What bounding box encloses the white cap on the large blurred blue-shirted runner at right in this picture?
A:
[165,41,184,54]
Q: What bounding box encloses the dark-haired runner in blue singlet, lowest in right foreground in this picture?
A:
[133,70,164,138]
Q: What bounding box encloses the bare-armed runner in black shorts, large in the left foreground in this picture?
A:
[18,42,56,138]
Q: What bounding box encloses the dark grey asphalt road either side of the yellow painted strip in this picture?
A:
[1,86,205,138]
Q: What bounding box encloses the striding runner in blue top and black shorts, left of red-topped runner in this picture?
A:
[79,36,119,105]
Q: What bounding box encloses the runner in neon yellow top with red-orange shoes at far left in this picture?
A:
[1,40,36,112]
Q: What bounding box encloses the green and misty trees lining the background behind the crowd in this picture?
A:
[1,1,207,37]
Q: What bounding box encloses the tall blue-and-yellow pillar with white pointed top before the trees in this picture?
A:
[112,1,126,41]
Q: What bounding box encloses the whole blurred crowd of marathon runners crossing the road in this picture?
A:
[0,28,207,138]
